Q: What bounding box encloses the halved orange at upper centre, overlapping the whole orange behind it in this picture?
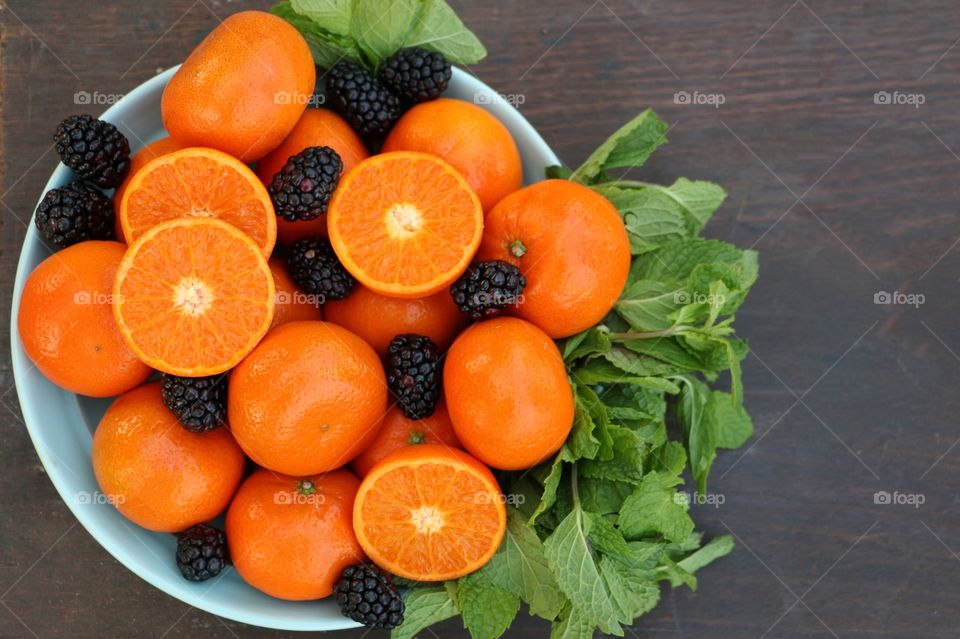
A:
[327,151,483,298]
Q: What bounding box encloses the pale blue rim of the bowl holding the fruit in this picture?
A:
[10,65,560,631]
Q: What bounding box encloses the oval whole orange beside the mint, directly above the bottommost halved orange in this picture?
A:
[443,317,573,470]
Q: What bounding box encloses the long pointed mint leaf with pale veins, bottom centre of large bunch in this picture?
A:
[543,504,622,636]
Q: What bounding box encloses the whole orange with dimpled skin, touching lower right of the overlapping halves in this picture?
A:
[227,322,387,476]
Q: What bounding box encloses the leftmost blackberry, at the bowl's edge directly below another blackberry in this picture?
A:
[34,180,114,248]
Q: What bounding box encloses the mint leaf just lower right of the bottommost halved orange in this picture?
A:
[481,508,566,621]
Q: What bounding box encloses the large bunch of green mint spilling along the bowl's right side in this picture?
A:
[393,110,759,639]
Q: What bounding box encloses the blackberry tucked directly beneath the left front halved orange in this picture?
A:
[160,373,227,433]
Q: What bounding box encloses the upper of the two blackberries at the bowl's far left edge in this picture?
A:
[53,115,130,189]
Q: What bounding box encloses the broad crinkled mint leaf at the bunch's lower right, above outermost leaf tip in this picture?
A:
[619,472,693,541]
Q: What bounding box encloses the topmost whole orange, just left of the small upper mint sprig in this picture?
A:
[161,11,316,162]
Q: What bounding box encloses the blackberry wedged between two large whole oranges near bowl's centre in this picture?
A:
[386,334,442,419]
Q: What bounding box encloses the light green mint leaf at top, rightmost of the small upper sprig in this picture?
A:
[403,0,487,64]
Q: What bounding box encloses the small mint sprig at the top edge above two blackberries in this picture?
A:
[271,0,487,71]
